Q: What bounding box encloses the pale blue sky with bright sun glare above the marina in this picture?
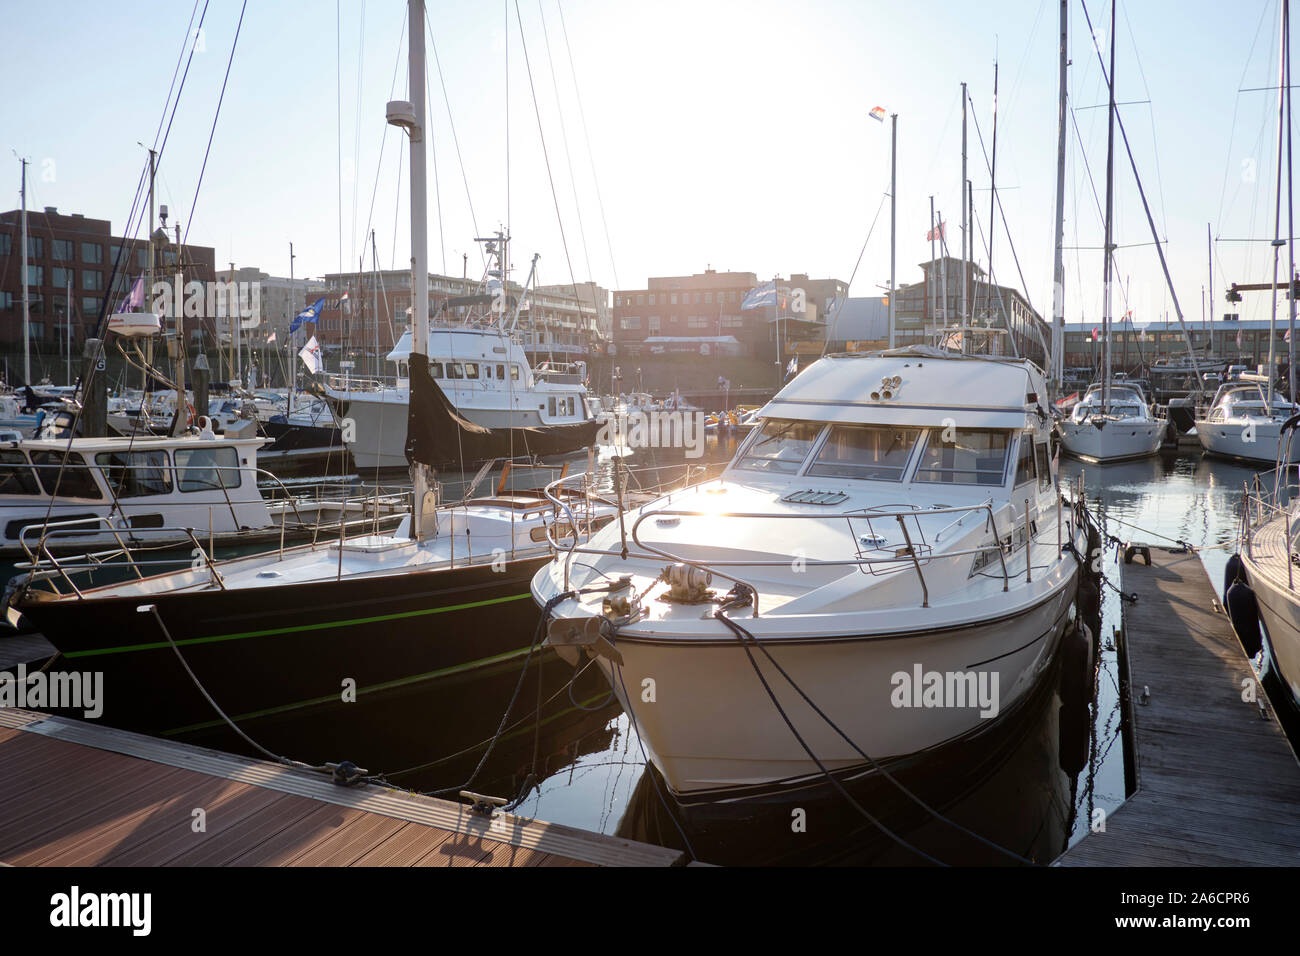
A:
[0,0,1287,324]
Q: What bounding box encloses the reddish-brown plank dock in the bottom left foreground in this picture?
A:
[0,709,684,866]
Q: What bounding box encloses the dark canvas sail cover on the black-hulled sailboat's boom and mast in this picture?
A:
[406,352,599,468]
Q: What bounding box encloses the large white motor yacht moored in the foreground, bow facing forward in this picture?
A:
[532,345,1084,804]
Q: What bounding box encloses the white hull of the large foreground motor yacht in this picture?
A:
[598,574,1075,799]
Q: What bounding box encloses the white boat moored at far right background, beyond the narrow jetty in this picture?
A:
[1196,376,1300,464]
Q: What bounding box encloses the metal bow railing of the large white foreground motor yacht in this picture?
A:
[547,463,1034,617]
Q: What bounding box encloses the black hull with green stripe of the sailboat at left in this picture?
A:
[18,557,547,734]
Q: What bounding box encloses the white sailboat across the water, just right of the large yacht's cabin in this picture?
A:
[1057,381,1166,462]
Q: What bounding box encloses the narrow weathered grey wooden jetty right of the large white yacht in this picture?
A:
[1054,546,1300,866]
